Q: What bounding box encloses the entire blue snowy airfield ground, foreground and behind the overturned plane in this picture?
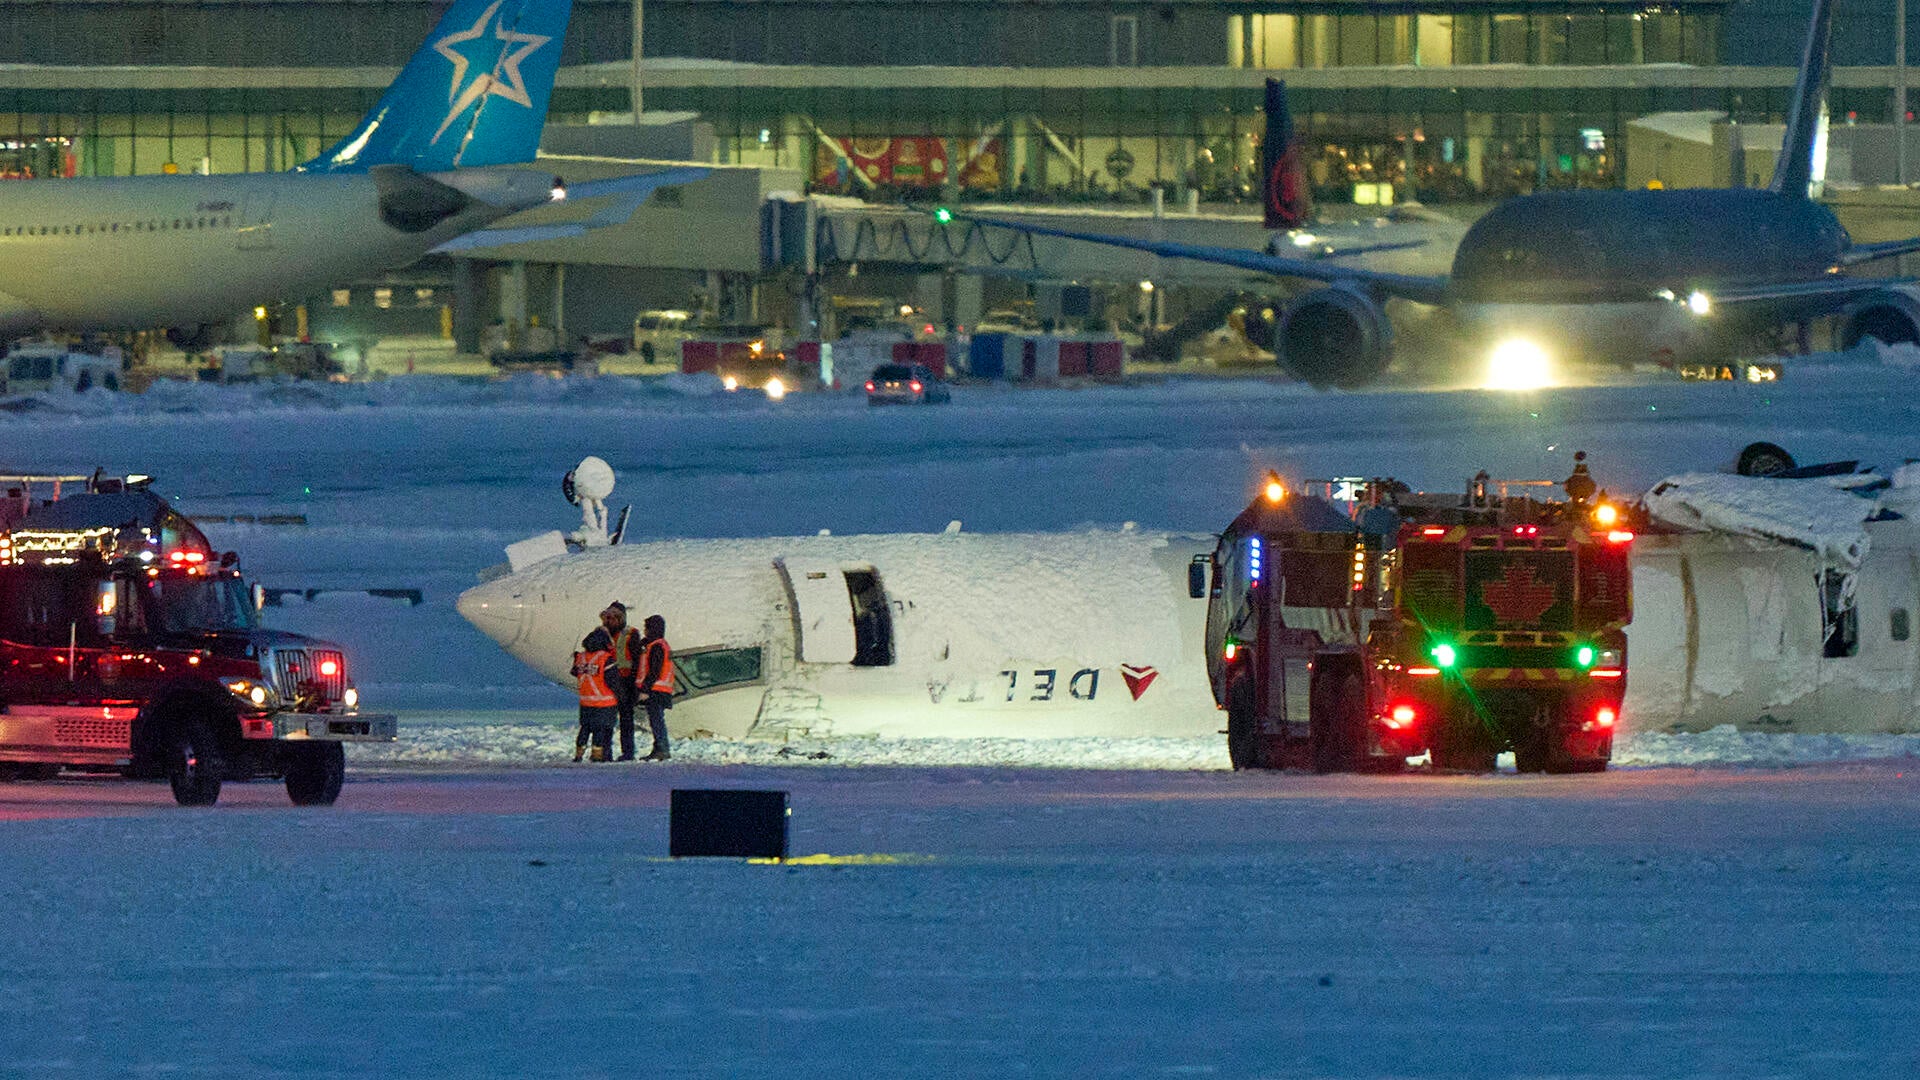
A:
[0,365,1920,1078]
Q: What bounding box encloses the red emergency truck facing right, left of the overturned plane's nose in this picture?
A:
[0,475,396,805]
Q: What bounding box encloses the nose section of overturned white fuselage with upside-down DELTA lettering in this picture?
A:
[459,532,1221,738]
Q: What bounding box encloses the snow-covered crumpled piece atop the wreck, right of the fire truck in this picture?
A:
[1644,473,1878,569]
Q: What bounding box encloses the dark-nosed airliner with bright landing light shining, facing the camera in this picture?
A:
[977,0,1920,388]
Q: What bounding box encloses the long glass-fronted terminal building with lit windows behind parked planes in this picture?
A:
[0,0,1893,202]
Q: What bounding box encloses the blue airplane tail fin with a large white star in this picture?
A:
[300,0,572,173]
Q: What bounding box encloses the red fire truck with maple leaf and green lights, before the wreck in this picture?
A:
[1188,455,1634,773]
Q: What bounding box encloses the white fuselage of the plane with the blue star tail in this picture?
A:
[0,169,553,332]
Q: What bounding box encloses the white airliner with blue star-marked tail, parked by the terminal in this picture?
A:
[0,0,705,344]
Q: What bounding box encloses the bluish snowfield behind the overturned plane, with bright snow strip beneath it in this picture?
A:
[0,352,1920,767]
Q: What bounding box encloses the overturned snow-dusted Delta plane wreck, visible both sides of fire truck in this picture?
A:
[459,447,1920,740]
